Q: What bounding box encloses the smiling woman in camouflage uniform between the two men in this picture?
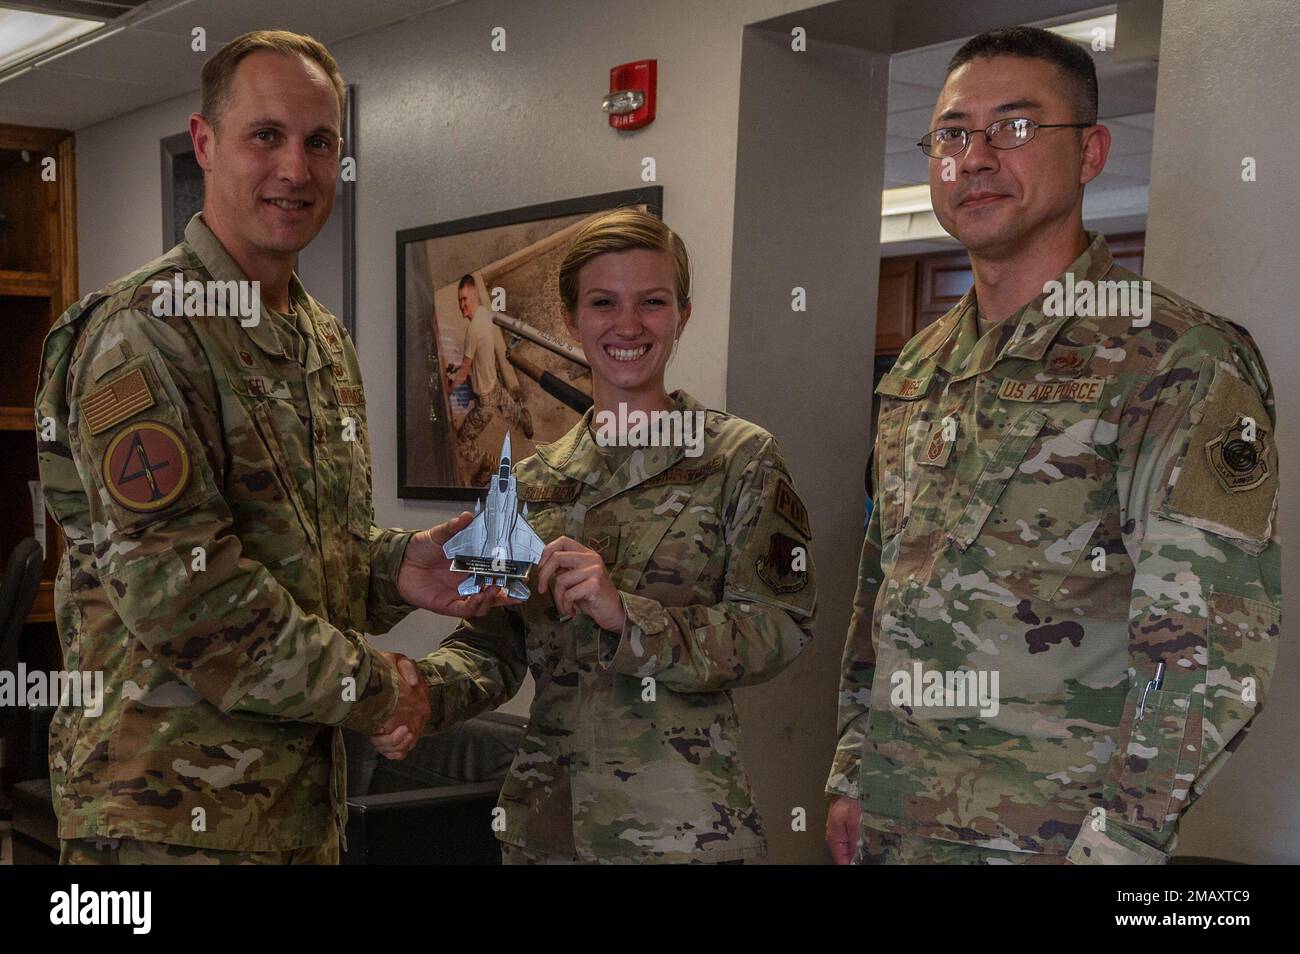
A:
[376,209,816,863]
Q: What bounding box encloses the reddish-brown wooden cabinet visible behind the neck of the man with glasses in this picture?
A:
[876,231,1147,356]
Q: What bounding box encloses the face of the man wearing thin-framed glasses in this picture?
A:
[930,56,1109,257]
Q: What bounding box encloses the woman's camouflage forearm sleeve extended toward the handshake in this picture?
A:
[416,607,528,734]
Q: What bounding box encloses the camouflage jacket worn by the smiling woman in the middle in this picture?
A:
[420,391,816,862]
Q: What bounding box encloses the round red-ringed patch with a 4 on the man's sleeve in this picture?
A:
[103,421,190,513]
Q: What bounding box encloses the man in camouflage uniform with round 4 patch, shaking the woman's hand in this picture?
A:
[36,32,496,863]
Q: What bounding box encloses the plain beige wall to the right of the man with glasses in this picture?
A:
[1145,0,1300,864]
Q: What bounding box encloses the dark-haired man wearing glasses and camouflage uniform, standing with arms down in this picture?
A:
[827,27,1281,864]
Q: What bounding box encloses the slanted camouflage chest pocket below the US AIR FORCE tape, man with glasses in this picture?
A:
[948,408,1114,600]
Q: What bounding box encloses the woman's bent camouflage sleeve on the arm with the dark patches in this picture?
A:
[601,438,816,693]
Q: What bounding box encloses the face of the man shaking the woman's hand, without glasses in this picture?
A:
[191,51,341,260]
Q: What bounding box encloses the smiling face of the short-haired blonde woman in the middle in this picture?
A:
[564,248,690,408]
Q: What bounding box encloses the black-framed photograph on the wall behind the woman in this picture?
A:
[397,186,663,500]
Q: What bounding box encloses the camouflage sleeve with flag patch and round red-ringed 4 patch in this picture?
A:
[68,305,397,732]
